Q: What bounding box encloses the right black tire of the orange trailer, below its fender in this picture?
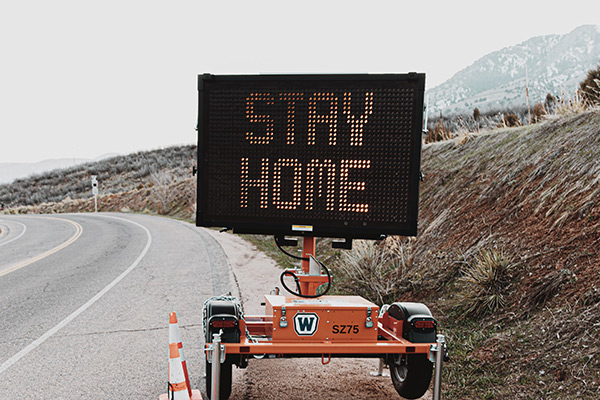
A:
[390,354,433,399]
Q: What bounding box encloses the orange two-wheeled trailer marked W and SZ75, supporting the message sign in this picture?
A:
[204,238,446,399]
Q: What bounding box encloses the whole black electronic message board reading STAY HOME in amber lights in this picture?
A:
[196,73,425,239]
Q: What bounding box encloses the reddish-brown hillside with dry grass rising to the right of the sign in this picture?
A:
[412,111,600,399]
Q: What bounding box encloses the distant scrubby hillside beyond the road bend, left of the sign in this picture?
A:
[0,145,196,218]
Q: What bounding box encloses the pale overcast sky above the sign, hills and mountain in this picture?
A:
[0,0,600,163]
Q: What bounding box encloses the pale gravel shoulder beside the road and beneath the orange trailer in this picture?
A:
[208,230,431,400]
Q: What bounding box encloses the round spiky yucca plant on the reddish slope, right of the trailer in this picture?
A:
[458,248,516,316]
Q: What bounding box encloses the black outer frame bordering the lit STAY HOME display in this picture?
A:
[196,72,425,239]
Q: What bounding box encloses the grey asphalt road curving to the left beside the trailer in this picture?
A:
[0,213,237,399]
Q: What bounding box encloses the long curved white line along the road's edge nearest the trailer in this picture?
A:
[0,215,152,374]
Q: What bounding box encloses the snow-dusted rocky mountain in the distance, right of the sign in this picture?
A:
[427,25,600,116]
